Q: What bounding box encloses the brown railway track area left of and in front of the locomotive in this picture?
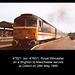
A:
[0,37,30,50]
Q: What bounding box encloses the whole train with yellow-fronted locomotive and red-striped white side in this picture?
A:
[12,14,66,46]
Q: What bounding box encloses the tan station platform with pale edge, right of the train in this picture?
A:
[32,37,75,50]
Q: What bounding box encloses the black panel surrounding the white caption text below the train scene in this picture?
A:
[0,50,75,73]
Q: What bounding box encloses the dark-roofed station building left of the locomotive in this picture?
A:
[0,21,14,37]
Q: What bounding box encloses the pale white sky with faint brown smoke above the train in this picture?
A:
[0,3,75,33]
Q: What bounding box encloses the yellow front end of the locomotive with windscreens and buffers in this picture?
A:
[12,16,38,46]
